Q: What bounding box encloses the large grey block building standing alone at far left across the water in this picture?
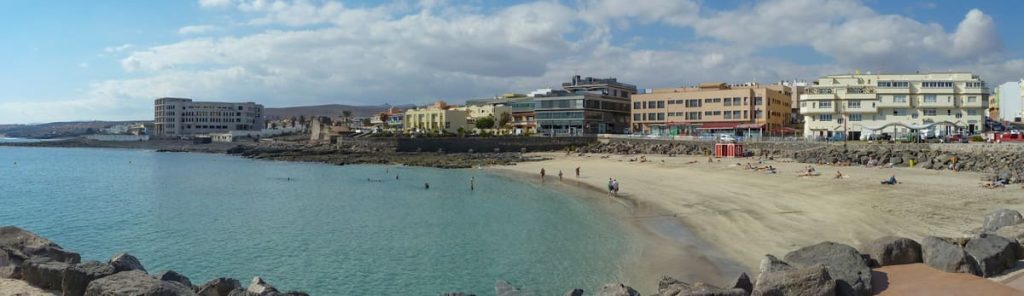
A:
[154,97,263,137]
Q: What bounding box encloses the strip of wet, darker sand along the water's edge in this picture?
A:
[485,165,752,291]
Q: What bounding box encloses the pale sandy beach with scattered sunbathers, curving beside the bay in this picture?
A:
[492,150,1024,287]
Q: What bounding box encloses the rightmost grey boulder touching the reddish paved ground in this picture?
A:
[964,234,1020,278]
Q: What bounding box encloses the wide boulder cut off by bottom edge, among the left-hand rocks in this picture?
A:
[85,270,196,296]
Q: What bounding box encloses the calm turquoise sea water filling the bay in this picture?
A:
[0,146,632,295]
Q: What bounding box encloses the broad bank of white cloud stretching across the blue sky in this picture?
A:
[6,0,1024,122]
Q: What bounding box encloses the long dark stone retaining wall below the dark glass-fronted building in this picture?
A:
[396,137,597,153]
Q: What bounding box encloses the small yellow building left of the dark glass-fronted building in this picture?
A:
[402,100,472,133]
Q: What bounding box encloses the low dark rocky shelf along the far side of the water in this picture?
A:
[227,143,530,168]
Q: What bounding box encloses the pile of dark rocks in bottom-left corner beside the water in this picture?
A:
[0,226,308,296]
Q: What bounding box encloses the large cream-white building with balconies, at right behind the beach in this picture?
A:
[800,72,988,139]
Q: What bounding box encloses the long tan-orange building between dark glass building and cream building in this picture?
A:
[632,83,792,136]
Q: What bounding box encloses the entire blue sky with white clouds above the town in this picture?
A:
[0,0,1024,124]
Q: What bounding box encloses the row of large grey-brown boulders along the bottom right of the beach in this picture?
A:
[441,209,1024,296]
